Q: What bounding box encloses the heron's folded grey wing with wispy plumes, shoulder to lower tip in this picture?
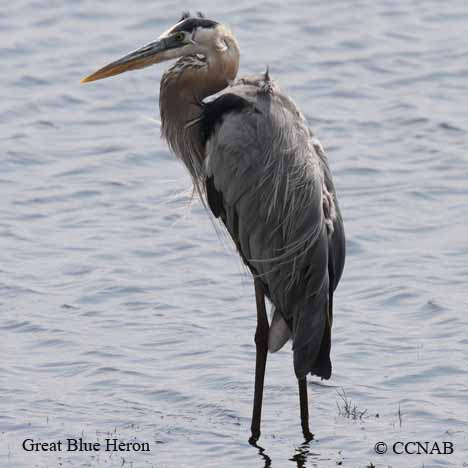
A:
[205,75,344,378]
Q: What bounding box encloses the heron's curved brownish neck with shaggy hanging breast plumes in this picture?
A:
[159,38,239,188]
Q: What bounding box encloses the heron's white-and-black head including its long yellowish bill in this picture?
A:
[81,13,238,83]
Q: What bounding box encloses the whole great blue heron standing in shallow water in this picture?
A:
[82,13,345,444]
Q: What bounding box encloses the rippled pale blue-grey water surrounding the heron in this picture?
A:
[0,0,468,468]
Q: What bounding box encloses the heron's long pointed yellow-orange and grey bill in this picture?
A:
[81,36,184,83]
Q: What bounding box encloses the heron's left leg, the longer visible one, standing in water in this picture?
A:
[249,279,269,445]
